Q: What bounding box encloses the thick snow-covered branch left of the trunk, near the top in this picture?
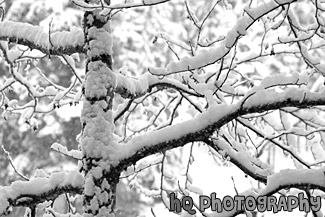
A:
[0,21,84,55]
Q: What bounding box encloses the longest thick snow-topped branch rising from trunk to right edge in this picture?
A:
[119,87,325,170]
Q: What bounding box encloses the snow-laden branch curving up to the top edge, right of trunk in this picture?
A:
[150,0,296,75]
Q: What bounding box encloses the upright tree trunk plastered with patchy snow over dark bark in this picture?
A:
[80,2,119,217]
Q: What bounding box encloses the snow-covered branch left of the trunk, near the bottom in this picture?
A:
[0,171,84,216]
